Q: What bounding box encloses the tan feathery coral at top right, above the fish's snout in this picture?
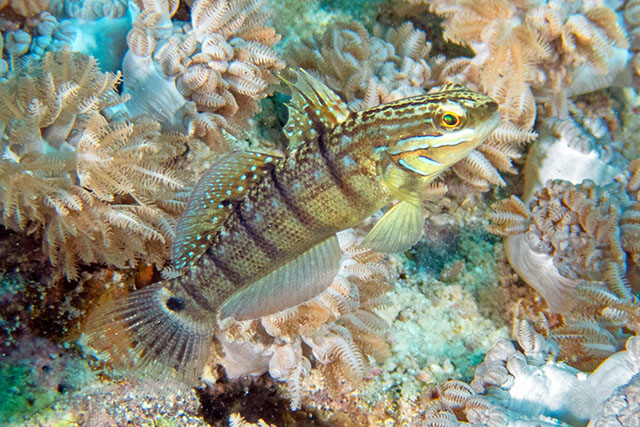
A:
[430,0,629,122]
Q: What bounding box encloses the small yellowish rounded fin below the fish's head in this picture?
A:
[361,201,424,252]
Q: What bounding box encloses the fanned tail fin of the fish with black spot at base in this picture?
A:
[85,282,215,386]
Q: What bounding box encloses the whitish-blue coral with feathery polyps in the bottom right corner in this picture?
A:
[425,322,640,426]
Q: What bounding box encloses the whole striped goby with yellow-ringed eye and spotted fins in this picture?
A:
[88,72,499,382]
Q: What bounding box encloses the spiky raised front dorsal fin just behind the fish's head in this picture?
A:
[280,69,349,149]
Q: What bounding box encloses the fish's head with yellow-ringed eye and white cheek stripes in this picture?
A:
[384,85,500,180]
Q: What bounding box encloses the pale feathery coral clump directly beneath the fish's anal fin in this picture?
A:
[215,230,390,409]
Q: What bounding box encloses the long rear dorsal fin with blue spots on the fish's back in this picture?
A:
[173,151,279,269]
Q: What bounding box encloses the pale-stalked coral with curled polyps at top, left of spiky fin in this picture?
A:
[123,0,284,146]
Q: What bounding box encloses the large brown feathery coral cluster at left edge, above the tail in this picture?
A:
[0,51,187,279]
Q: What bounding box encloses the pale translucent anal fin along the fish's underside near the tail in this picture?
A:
[220,236,342,320]
